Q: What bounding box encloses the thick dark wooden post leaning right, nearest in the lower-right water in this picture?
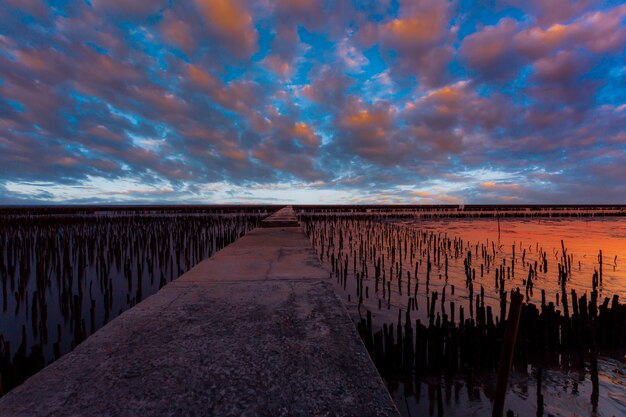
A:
[492,292,522,417]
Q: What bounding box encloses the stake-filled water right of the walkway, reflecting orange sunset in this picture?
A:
[299,207,626,415]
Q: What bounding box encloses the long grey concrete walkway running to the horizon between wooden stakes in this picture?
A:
[0,208,398,417]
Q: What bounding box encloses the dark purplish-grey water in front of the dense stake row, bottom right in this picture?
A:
[386,358,626,417]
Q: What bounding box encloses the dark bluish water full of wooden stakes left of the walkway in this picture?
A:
[0,208,267,395]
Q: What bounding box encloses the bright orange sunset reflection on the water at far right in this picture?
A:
[404,217,626,301]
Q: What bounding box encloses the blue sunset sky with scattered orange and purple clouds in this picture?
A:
[0,0,626,204]
